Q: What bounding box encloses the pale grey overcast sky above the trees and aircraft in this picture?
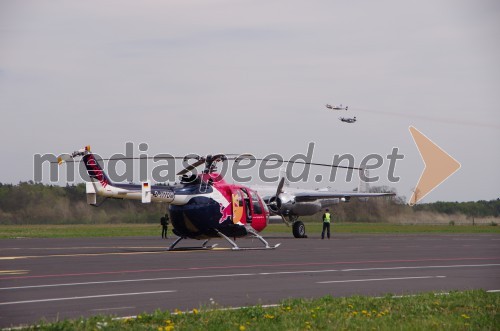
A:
[0,0,500,202]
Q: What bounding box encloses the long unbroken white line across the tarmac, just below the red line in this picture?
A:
[0,264,500,291]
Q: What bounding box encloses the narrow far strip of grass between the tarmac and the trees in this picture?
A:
[0,222,500,238]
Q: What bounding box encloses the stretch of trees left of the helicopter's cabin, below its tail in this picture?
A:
[0,181,166,224]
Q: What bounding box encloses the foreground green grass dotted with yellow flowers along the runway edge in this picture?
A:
[18,290,500,331]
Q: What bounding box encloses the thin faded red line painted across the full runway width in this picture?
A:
[0,257,500,280]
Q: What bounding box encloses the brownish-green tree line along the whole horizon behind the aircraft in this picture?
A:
[0,181,500,224]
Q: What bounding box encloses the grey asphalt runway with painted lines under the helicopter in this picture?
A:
[0,232,500,328]
